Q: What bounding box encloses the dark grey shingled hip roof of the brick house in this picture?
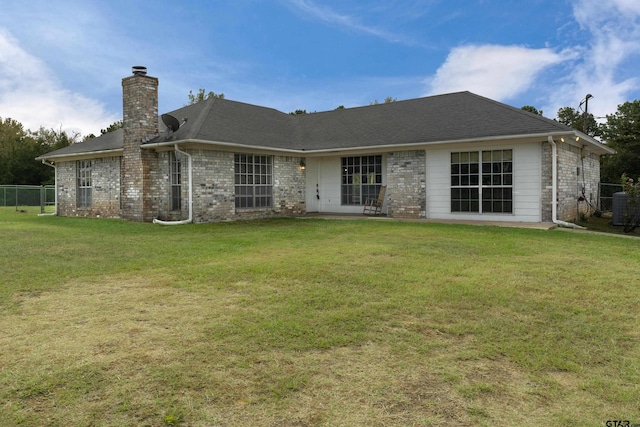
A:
[40,92,611,159]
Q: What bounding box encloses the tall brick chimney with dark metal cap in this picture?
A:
[120,66,158,221]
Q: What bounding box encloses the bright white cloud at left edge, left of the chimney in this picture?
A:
[0,29,119,135]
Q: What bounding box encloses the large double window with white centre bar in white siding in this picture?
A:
[451,150,513,213]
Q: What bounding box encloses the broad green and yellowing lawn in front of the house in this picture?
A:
[0,209,640,426]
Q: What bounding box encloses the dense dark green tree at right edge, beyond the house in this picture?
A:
[600,100,640,182]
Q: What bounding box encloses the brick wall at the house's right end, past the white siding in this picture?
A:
[542,141,600,222]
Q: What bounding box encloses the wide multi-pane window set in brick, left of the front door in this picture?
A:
[234,154,273,209]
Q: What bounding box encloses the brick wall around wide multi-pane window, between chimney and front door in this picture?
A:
[155,149,306,223]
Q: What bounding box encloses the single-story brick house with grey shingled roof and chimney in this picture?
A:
[38,67,613,224]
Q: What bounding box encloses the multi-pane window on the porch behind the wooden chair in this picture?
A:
[341,156,382,205]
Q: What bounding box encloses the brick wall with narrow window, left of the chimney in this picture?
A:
[56,157,121,218]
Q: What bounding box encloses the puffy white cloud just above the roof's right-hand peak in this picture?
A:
[427,45,574,101]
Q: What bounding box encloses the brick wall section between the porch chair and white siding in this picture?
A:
[387,150,427,218]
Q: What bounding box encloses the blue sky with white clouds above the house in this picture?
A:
[0,0,640,135]
